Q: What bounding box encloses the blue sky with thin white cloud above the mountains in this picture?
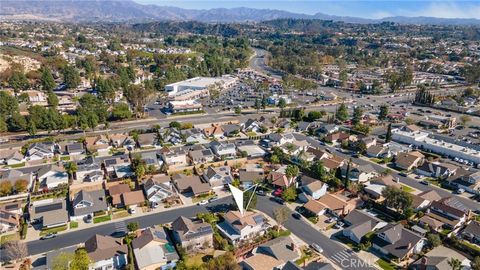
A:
[134,0,480,19]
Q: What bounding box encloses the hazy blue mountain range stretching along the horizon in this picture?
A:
[0,0,480,25]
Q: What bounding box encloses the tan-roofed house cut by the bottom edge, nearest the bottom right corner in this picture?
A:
[409,245,471,270]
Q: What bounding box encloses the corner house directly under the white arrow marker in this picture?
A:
[217,211,270,245]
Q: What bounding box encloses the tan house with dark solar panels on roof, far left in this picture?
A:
[29,199,68,228]
